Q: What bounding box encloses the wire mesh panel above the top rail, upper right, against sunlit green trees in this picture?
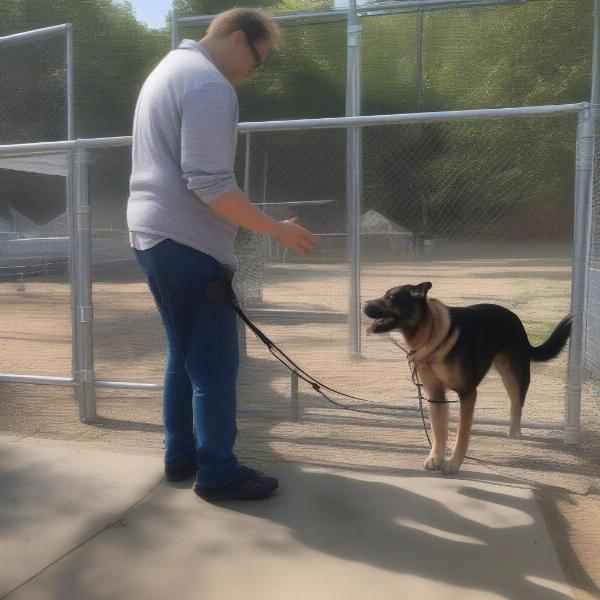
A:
[361,0,594,114]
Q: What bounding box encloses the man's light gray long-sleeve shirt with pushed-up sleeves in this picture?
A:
[127,40,239,268]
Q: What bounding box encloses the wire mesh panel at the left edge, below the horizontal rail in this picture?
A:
[0,154,71,377]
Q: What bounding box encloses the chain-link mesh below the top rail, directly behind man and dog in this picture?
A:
[64,109,576,427]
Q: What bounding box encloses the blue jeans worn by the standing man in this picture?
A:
[135,240,240,485]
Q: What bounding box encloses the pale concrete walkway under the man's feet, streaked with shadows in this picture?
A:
[0,437,572,600]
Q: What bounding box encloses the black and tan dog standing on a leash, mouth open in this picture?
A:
[363,282,572,475]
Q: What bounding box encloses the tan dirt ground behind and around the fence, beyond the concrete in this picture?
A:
[0,259,600,600]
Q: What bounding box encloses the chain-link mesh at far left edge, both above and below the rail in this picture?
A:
[0,26,72,377]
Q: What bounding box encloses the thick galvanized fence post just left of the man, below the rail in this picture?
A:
[71,147,96,423]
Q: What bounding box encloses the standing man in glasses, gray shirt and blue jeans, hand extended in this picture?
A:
[127,8,316,500]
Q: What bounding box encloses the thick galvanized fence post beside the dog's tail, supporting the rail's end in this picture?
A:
[564,106,594,444]
